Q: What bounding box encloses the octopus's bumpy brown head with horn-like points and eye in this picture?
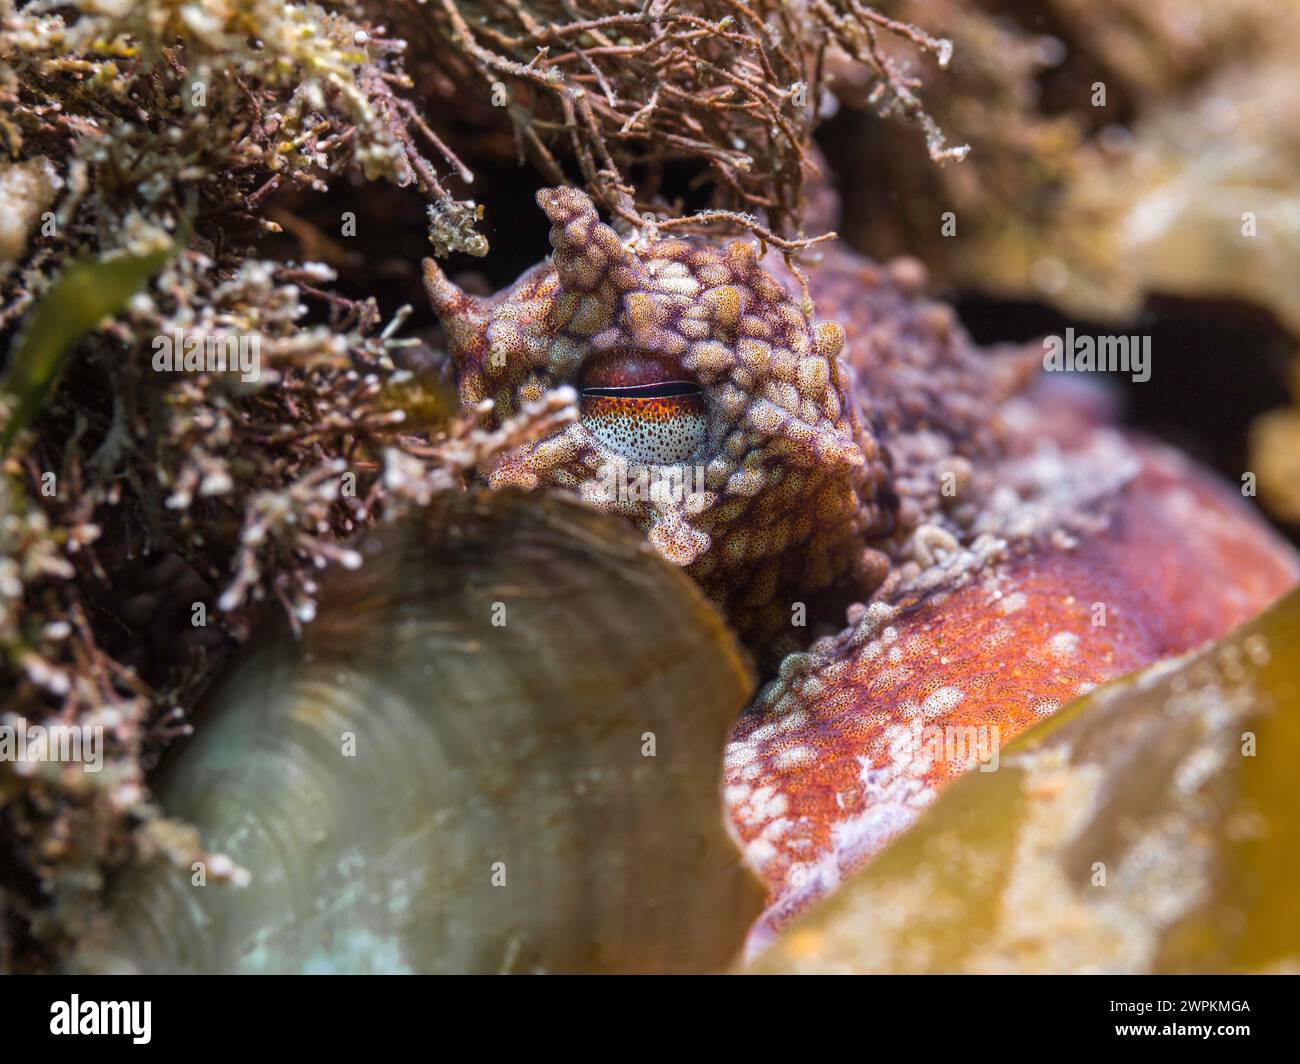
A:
[425,187,887,645]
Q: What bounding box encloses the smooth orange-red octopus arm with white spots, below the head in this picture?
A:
[725,441,1300,940]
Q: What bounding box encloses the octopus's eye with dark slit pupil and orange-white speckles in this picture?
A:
[580,358,706,466]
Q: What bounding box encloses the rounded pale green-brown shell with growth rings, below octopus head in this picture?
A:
[78,493,762,972]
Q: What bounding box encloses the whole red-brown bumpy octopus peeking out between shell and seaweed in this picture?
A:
[425,189,1300,944]
